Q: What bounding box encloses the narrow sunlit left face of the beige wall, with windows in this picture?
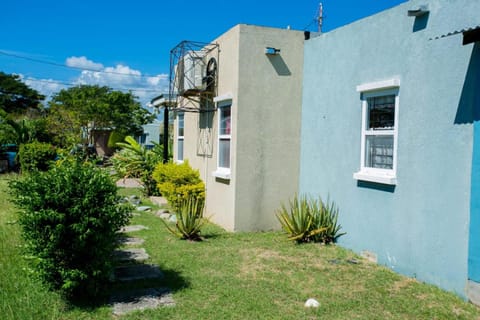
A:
[174,26,239,231]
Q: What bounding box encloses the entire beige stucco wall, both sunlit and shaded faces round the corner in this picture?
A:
[174,25,303,231]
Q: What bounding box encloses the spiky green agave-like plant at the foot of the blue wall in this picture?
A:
[277,195,345,244]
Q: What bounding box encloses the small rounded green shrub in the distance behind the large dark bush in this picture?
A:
[18,141,56,172]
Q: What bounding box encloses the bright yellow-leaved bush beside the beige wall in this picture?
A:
[153,161,205,211]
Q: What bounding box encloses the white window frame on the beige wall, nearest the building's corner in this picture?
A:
[212,94,233,180]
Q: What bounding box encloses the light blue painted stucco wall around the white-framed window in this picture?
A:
[300,0,480,296]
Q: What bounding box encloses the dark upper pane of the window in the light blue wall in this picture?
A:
[367,95,395,130]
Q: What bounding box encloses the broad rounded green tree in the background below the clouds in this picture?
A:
[48,85,154,146]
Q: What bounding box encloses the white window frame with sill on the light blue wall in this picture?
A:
[353,78,400,185]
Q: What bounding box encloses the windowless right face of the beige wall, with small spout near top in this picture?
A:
[235,25,304,230]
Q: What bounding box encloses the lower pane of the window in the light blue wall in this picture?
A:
[365,135,393,169]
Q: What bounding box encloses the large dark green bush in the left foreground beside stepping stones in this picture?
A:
[10,161,130,297]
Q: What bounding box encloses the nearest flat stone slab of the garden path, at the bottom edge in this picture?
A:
[110,288,175,316]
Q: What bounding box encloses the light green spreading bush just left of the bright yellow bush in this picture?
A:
[110,136,162,196]
